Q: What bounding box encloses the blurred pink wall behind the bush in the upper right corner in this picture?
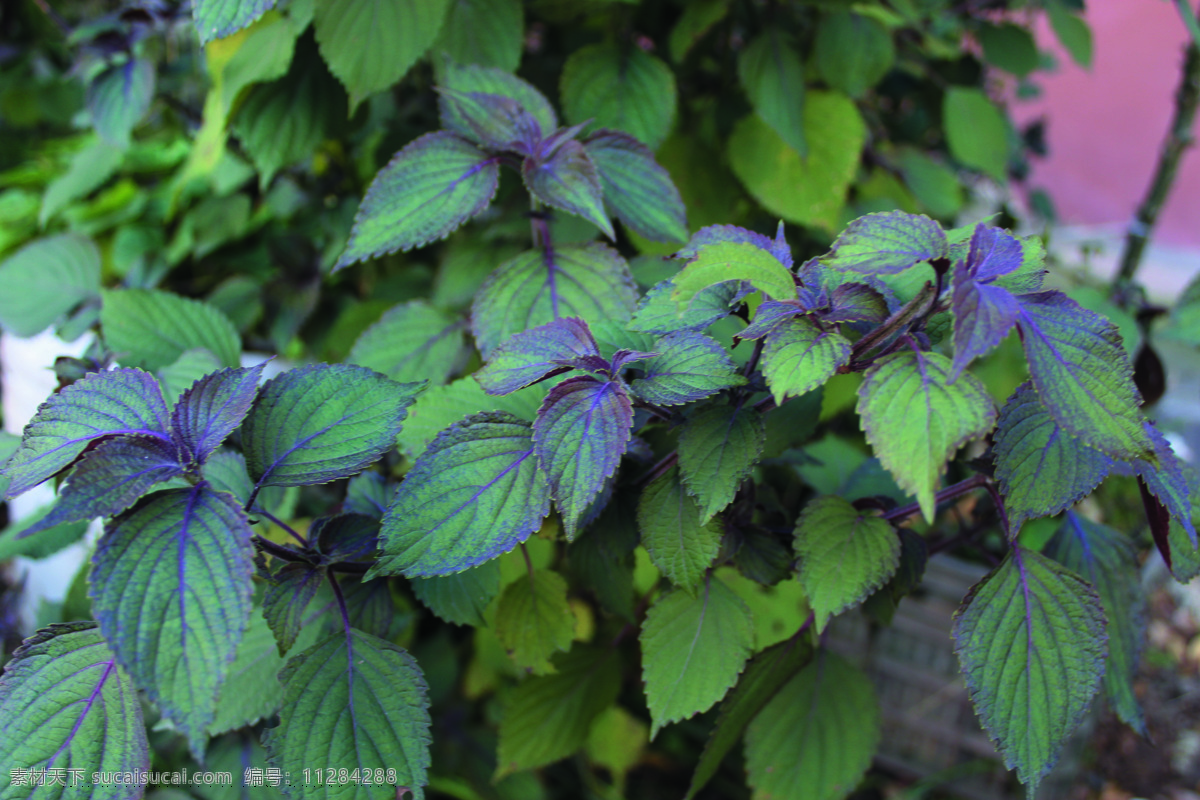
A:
[1012,0,1200,247]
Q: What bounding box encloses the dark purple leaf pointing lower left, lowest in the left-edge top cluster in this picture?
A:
[20,437,184,537]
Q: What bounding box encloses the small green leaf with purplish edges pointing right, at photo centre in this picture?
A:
[631,331,746,405]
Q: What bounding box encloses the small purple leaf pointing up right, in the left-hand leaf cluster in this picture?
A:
[170,361,266,464]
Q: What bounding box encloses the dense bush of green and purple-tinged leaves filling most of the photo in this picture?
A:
[0,0,1200,798]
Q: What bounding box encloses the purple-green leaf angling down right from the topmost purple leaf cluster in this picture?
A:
[583,130,688,242]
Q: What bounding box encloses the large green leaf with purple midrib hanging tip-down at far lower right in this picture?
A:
[954,545,1105,796]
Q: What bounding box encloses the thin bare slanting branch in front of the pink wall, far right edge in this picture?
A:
[1112,32,1200,289]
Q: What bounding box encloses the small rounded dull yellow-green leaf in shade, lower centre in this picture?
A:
[496,570,575,675]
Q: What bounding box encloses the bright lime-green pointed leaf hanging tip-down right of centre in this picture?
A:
[858,350,996,522]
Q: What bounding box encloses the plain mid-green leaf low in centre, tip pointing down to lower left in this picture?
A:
[640,578,754,739]
